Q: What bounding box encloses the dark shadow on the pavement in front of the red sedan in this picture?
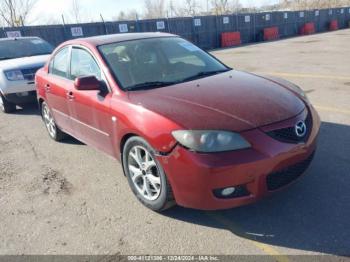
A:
[164,123,350,256]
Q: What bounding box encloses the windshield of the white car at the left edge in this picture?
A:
[0,38,53,60]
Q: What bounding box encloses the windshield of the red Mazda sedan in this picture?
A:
[99,37,230,90]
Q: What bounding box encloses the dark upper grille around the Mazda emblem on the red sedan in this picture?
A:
[267,110,312,144]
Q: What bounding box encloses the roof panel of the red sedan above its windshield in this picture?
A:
[71,32,176,46]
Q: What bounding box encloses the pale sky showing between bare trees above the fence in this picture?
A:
[30,0,277,24]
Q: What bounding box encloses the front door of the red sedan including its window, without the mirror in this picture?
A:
[68,46,114,155]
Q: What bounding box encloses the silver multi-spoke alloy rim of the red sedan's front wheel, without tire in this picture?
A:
[128,146,161,201]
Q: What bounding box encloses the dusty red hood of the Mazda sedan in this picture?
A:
[129,71,305,132]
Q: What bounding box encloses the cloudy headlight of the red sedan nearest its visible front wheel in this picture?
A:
[172,130,251,153]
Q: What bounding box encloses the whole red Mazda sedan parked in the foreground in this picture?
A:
[36,33,320,211]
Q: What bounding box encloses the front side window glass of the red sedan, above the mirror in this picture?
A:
[70,48,101,80]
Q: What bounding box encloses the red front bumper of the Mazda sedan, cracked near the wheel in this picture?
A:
[158,107,320,210]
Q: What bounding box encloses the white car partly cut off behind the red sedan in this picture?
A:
[0,37,53,113]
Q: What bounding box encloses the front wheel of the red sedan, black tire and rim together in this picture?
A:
[123,136,176,212]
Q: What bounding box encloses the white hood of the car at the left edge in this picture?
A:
[0,55,50,71]
